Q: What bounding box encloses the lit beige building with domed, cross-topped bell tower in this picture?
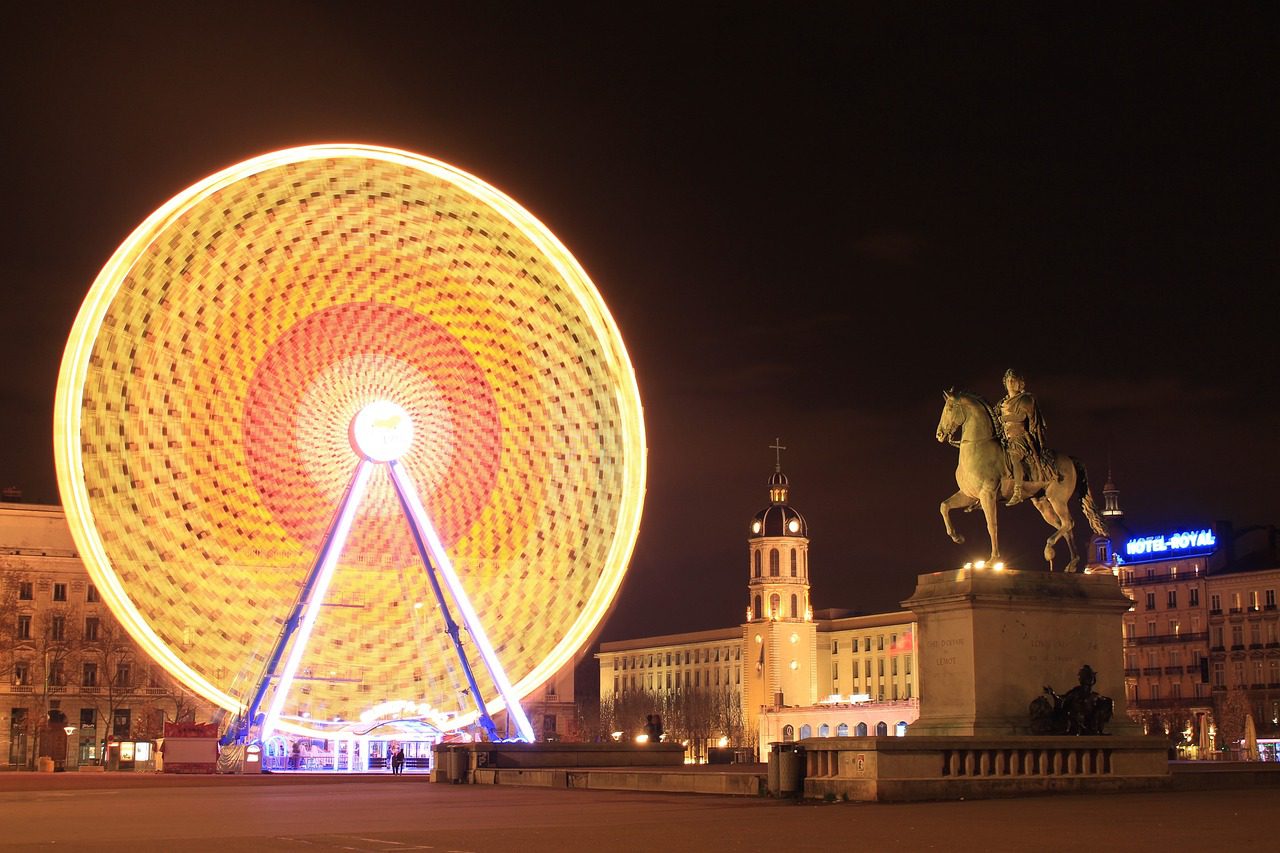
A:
[596,466,919,749]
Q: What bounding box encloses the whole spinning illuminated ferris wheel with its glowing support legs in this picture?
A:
[55,145,645,739]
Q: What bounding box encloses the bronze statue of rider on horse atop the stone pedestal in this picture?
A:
[937,370,1107,571]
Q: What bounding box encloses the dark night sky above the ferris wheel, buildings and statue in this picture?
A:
[0,3,1280,648]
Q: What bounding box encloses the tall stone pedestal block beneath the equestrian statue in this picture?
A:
[902,569,1140,738]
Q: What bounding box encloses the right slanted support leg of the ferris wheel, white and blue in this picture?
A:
[387,461,534,743]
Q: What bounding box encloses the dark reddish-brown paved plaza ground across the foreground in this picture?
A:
[0,774,1280,853]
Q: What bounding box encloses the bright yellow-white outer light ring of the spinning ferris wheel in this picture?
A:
[54,145,646,727]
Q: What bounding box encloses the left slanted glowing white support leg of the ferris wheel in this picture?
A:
[243,460,372,742]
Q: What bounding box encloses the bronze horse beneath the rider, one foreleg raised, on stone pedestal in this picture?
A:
[937,391,1107,571]
